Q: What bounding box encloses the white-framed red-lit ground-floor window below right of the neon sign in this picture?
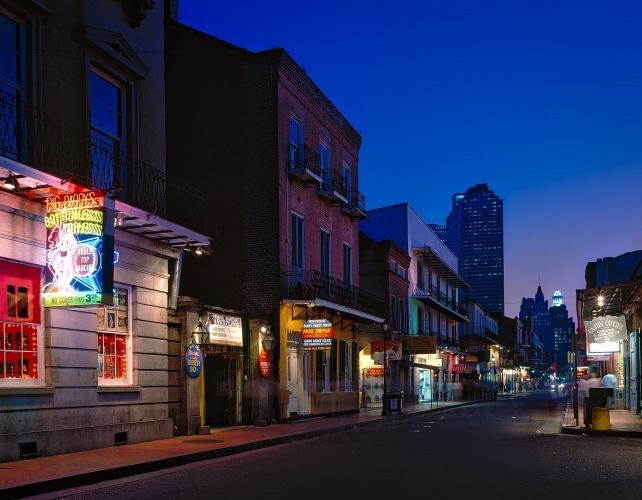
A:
[97,288,132,385]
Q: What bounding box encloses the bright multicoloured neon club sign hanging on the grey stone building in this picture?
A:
[42,191,114,307]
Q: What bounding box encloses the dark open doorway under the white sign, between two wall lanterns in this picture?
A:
[203,354,243,427]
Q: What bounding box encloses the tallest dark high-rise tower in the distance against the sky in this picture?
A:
[442,184,504,314]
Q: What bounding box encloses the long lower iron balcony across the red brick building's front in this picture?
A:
[281,271,385,317]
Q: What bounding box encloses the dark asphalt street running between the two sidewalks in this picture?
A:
[36,392,642,500]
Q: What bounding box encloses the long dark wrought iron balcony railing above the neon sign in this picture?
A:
[0,92,207,234]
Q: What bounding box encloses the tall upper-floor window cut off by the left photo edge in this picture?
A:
[0,11,28,160]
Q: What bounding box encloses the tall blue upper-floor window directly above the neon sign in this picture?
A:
[89,68,127,193]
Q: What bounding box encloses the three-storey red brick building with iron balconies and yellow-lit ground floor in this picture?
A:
[167,23,384,425]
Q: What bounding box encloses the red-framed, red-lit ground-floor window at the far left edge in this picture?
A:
[0,261,42,380]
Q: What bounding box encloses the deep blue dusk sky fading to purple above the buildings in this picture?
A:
[179,0,642,318]
